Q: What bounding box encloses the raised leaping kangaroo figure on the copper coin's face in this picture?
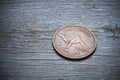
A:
[59,33,89,51]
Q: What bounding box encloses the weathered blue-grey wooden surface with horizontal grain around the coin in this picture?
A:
[0,0,120,80]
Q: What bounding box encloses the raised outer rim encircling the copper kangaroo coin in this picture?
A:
[53,25,97,59]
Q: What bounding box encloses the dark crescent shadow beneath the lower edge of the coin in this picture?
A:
[53,47,97,61]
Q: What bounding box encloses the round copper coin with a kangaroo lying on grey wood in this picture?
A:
[53,26,96,59]
